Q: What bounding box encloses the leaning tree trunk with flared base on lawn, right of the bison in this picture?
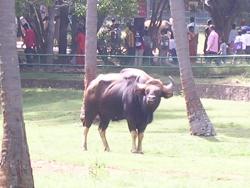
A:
[170,0,215,136]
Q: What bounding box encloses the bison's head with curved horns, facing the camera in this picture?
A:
[136,79,173,110]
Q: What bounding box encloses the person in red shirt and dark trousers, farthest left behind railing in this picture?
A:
[23,23,36,63]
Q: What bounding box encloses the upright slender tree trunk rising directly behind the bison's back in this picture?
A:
[85,0,97,88]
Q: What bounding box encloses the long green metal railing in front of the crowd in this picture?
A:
[18,53,250,68]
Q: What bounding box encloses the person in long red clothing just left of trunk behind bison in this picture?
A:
[76,28,85,65]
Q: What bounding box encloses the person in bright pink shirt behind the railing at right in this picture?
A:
[206,25,219,65]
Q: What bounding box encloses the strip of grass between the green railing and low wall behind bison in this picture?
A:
[21,65,250,86]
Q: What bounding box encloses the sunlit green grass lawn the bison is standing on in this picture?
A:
[1,89,250,188]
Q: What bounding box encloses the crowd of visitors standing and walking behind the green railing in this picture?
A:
[19,17,250,66]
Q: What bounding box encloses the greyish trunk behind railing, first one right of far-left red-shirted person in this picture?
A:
[46,5,56,64]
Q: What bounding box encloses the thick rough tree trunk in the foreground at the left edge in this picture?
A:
[0,0,34,188]
